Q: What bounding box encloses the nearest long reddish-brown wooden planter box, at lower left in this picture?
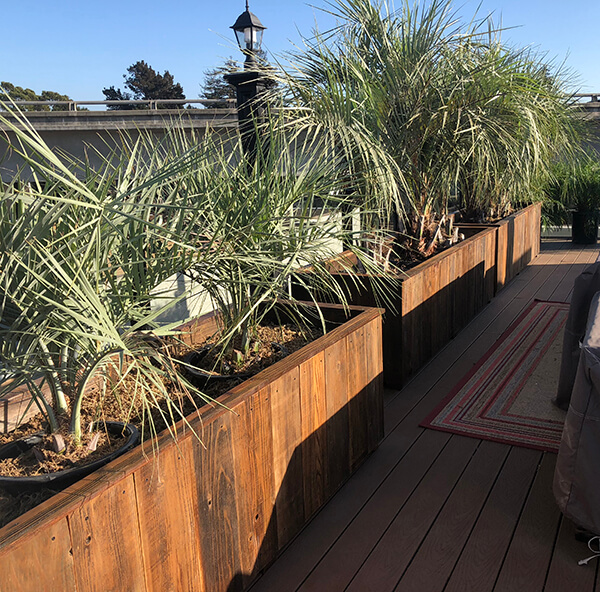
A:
[0,306,383,592]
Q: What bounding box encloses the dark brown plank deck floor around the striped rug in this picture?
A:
[252,239,600,592]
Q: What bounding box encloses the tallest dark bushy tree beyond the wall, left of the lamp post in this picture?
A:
[102,60,185,109]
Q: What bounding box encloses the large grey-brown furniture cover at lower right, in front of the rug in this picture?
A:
[554,292,600,534]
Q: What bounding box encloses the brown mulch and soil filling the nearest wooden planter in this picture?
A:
[0,325,318,527]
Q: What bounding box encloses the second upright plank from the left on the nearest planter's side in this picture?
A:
[69,476,146,592]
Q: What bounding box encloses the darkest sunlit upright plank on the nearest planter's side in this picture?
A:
[191,412,243,592]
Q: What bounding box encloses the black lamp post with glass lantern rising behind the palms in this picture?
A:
[225,0,266,164]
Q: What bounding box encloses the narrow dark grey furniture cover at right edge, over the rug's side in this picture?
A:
[555,263,600,411]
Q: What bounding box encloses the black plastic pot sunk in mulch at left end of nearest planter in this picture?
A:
[0,421,140,493]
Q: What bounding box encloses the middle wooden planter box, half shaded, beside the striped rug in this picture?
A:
[293,228,497,388]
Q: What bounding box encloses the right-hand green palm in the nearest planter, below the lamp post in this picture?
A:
[180,116,395,366]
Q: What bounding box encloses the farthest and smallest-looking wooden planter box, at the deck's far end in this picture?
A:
[458,203,542,293]
